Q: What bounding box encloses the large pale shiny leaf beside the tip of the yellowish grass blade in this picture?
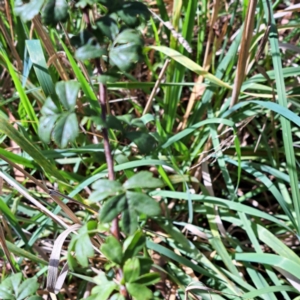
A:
[109,29,143,72]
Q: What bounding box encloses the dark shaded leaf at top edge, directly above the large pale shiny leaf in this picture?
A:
[116,1,150,27]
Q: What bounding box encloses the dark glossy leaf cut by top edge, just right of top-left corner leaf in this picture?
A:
[42,0,68,26]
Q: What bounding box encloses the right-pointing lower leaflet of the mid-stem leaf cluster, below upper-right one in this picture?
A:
[126,191,161,217]
